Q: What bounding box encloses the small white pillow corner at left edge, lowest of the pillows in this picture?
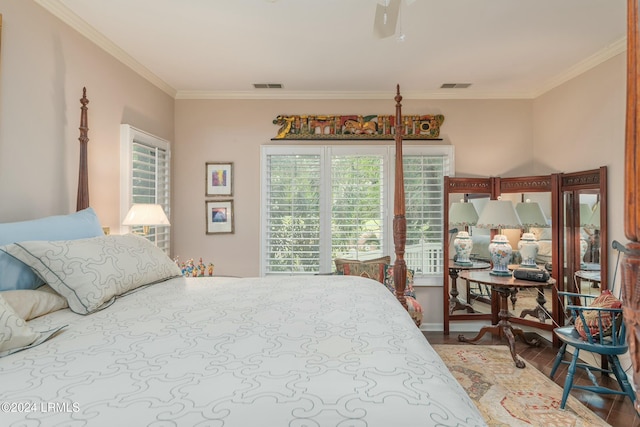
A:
[0,294,64,357]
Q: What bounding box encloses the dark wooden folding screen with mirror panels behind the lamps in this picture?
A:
[443,167,608,344]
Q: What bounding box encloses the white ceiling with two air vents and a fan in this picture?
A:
[36,0,626,99]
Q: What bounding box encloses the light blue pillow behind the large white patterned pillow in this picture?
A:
[0,208,104,291]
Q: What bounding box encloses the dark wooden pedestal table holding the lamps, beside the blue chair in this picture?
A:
[458,271,556,368]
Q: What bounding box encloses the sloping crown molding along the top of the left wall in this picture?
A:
[34,0,176,98]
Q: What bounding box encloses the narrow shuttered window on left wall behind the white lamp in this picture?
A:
[120,125,171,255]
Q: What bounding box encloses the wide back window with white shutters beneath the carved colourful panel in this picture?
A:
[261,146,453,276]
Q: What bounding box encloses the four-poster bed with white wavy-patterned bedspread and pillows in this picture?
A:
[0,89,486,427]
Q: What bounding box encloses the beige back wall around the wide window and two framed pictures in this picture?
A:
[172,96,533,276]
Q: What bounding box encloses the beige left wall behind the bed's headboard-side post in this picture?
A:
[0,0,174,228]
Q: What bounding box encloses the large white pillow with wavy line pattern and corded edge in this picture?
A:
[0,234,182,314]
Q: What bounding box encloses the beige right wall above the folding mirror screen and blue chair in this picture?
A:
[533,54,626,296]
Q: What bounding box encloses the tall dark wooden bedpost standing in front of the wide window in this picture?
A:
[393,85,407,308]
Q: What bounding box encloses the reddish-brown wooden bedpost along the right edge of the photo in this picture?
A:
[622,0,640,412]
